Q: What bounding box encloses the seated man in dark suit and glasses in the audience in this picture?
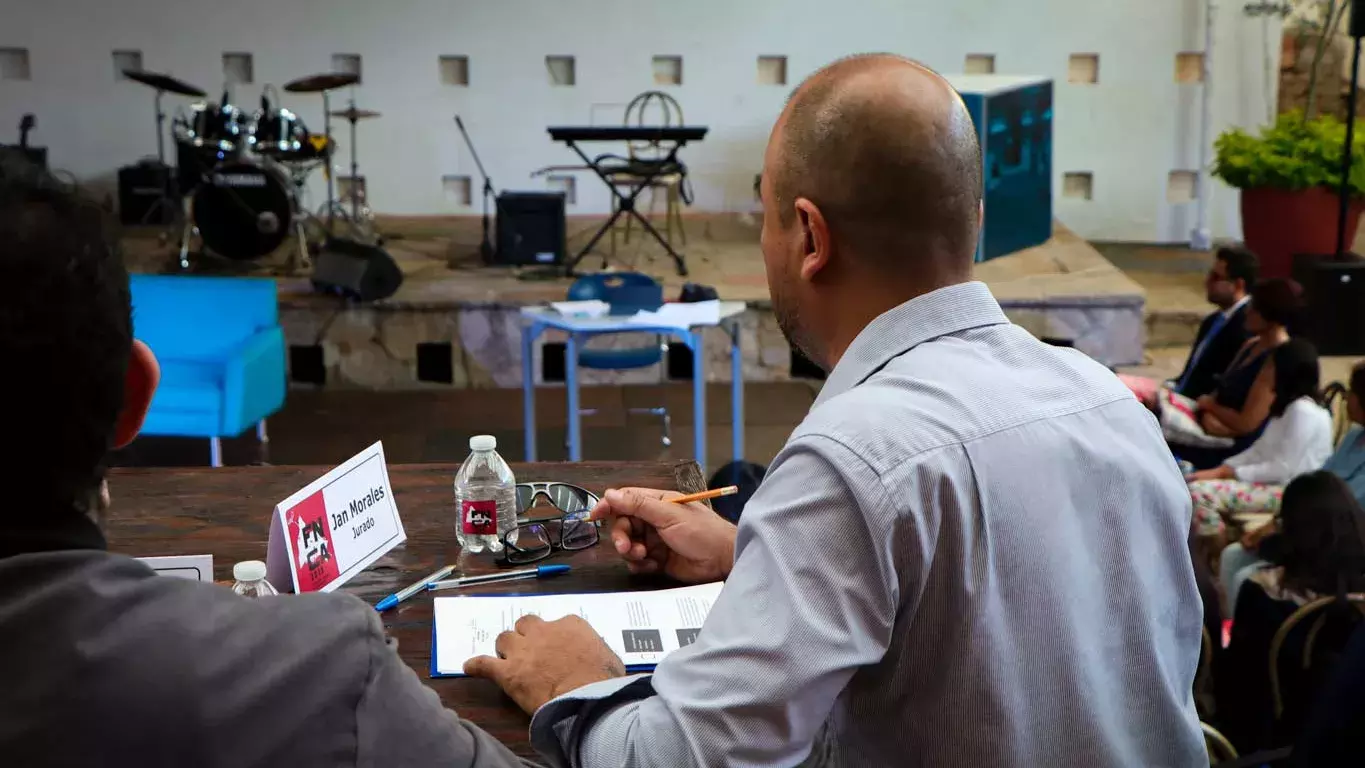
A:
[1119,247,1257,408]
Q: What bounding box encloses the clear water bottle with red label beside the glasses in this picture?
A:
[455,435,516,552]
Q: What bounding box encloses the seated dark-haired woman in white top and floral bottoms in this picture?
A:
[1186,338,1332,536]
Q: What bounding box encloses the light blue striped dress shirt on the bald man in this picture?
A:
[531,282,1208,768]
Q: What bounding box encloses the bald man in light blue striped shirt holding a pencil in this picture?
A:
[465,55,1208,768]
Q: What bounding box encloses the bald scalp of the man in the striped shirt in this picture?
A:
[771,55,981,271]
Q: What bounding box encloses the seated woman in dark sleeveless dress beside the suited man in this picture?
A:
[1158,280,1302,469]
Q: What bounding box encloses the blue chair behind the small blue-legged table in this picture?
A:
[566,271,673,447]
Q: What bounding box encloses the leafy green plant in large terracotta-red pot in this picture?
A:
[1213,112,1365,277]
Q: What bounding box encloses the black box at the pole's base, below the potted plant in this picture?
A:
[1294,254,1365,356]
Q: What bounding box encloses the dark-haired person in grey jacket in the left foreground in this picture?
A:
[0,161,537,768]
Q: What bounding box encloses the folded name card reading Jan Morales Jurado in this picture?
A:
[266,443,407,592]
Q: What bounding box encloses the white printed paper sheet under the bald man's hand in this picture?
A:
[431,582,725,675]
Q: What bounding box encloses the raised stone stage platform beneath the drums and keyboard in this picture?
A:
[126,214,1147,389]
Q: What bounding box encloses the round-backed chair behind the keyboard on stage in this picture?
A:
[599,90,691,256]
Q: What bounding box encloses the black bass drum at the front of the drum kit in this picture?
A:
[194,162,293,261]
